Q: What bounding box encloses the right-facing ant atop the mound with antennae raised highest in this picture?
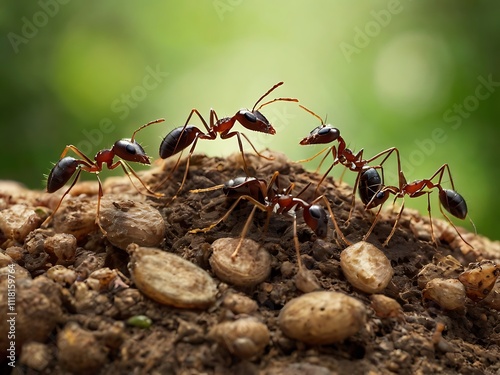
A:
[159,82,298,200]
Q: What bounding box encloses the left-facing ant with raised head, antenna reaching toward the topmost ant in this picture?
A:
[298,104,401,223]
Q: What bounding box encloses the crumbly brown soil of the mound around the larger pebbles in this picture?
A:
[0,154,500,374]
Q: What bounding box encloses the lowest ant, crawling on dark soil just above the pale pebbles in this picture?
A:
[189,172,351,272]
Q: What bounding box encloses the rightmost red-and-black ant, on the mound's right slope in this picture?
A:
[359,164,475,248]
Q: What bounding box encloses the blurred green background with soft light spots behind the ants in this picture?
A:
[0,0,500,239]
